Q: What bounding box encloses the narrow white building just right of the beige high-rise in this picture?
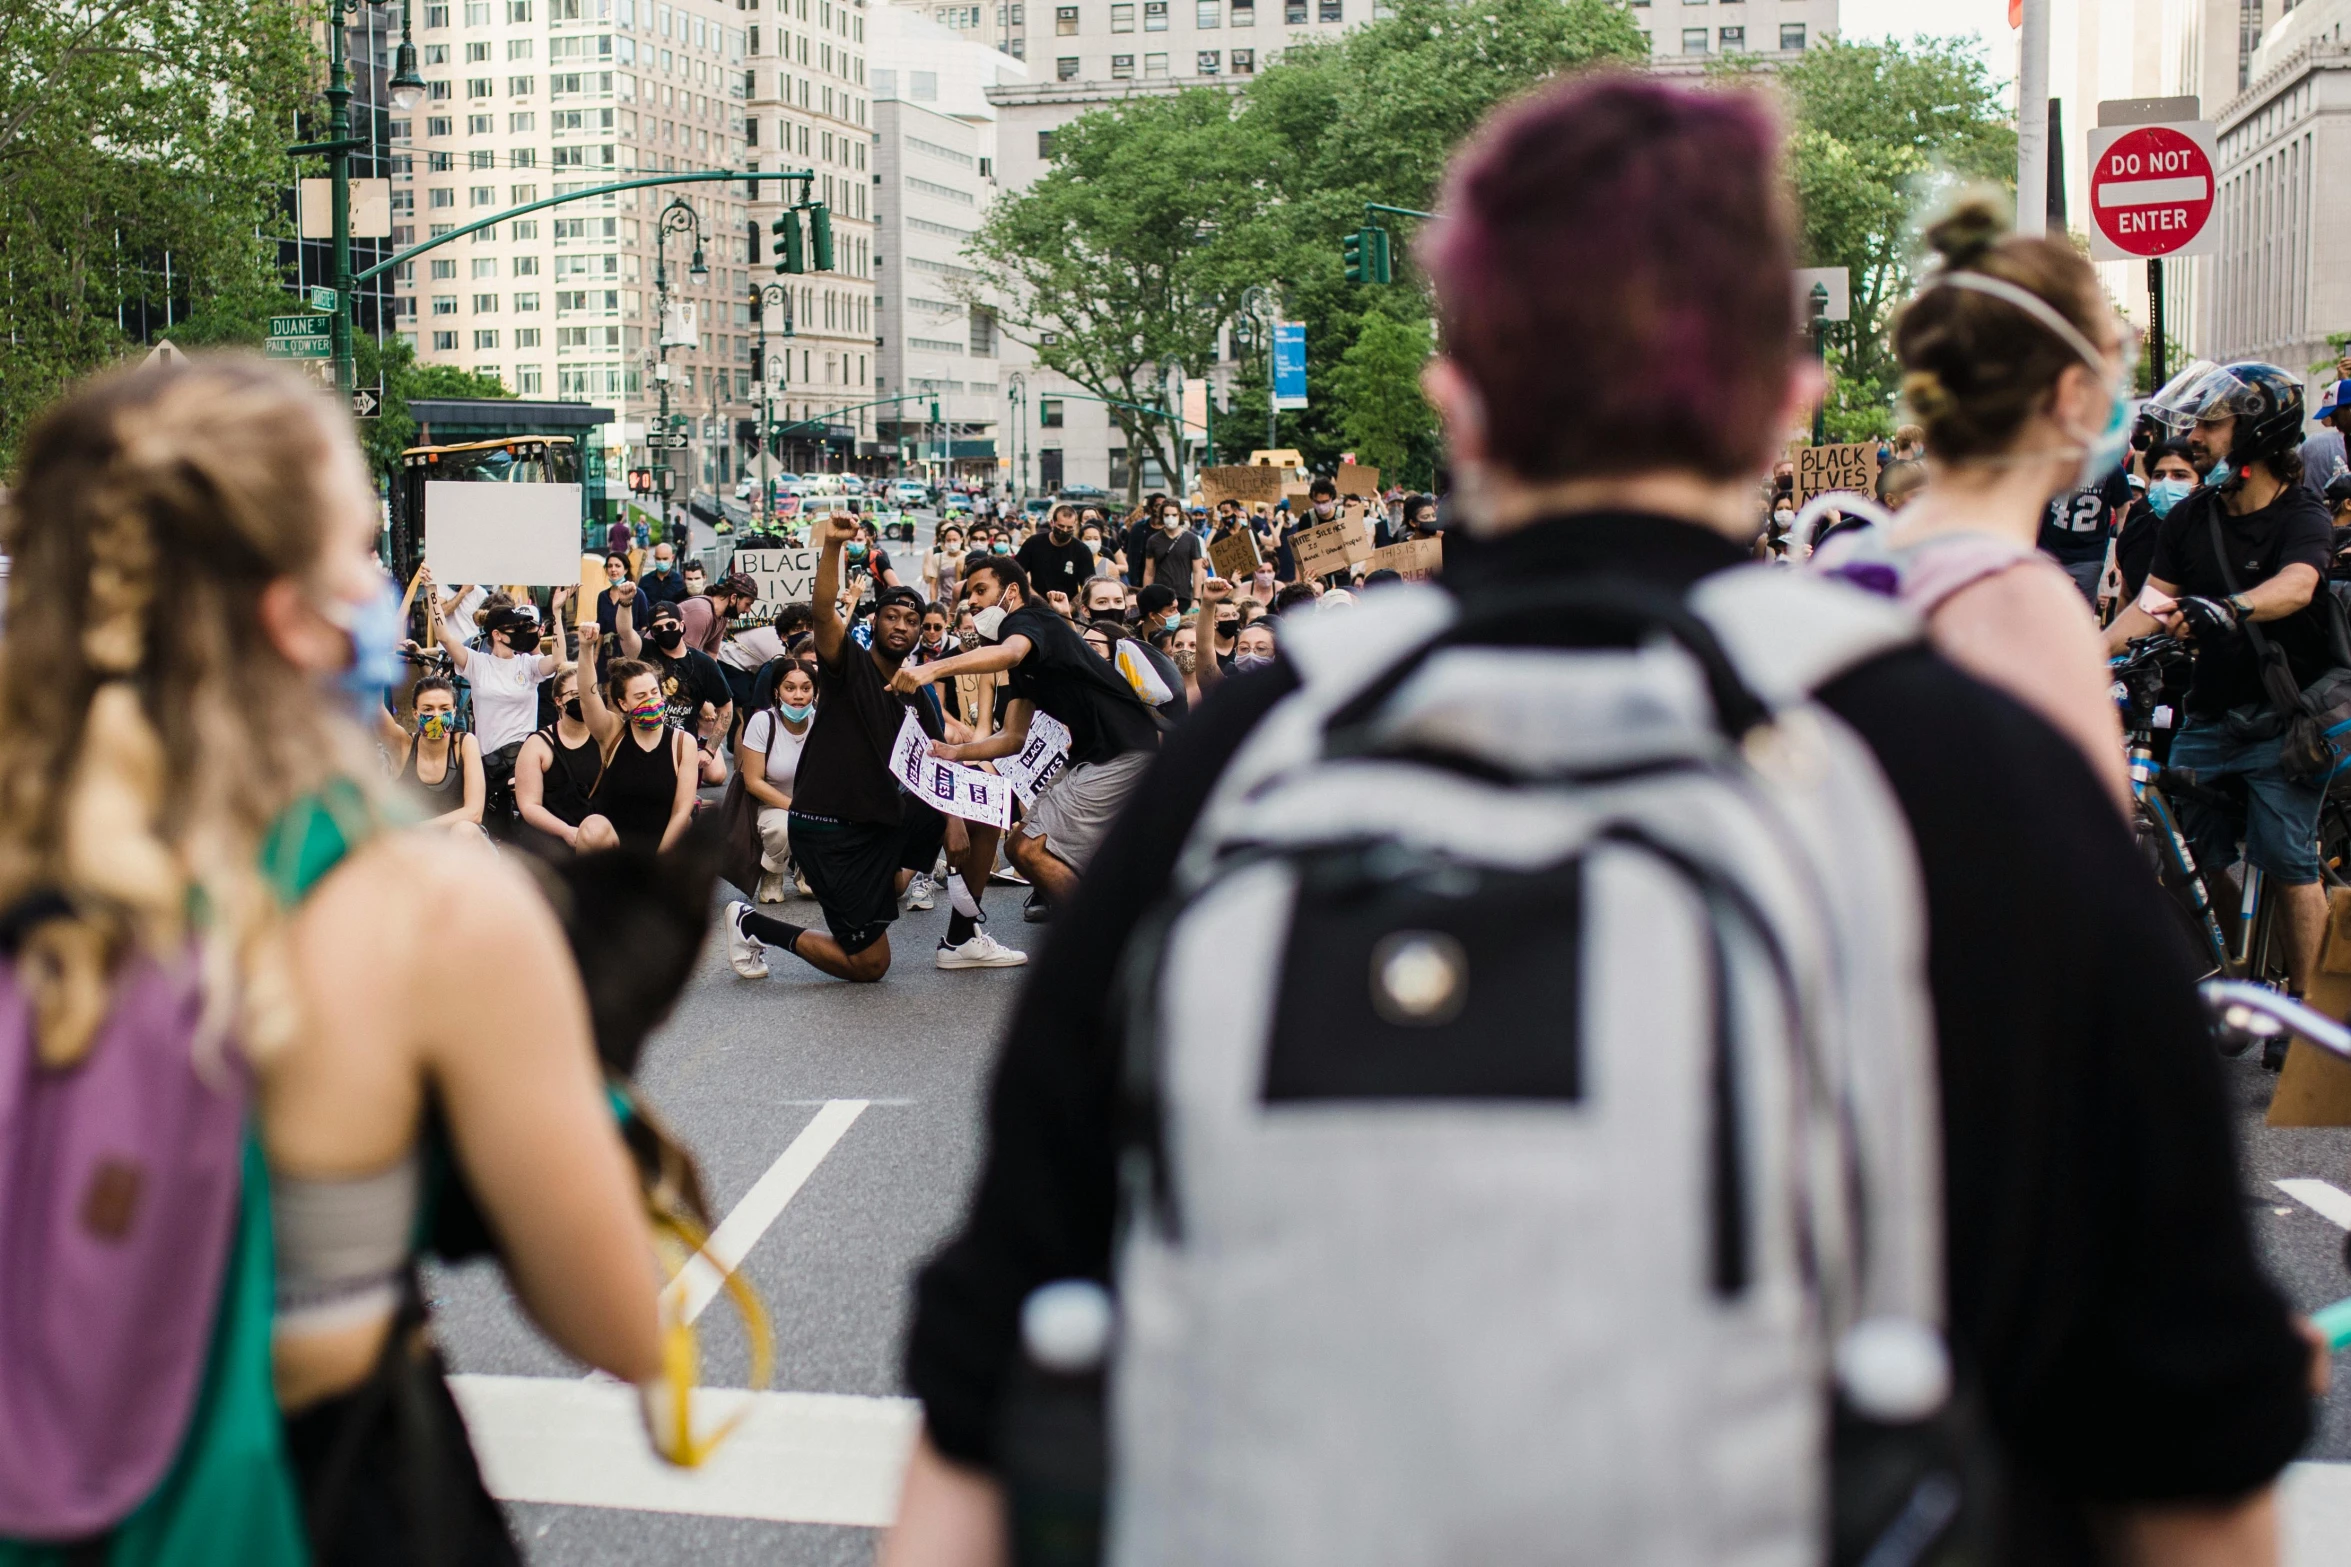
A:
[872,5,1027,482]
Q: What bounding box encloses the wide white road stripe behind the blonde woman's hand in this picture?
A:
[449,1377,922,1529]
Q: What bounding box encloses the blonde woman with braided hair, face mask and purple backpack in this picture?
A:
[0,357,661,1567]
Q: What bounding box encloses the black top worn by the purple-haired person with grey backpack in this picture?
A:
[907,517,2311,1567]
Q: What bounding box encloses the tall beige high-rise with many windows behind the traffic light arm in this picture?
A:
[393,0,870,505]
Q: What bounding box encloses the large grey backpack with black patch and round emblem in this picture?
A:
[1110,566,1961,1567]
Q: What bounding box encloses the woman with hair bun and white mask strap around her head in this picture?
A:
[1815,197,2135,813]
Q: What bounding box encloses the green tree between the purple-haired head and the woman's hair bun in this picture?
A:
[1721,38,2017,439]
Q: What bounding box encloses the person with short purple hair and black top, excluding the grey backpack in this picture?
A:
[879,75,2311,1567]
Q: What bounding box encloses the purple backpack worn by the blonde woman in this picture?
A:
[0,956,247,1539]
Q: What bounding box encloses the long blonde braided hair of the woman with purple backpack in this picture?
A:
[0,355,369,1067]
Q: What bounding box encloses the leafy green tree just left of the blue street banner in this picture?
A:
[959,87,1272,500]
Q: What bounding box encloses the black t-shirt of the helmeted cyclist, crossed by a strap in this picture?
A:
[2146,484,2335,717]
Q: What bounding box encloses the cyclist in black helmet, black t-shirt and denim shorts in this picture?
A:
[2106,362,2335,994]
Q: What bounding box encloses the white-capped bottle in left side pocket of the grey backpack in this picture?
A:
[997,1278,1112,1567]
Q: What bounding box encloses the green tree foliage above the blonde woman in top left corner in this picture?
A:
[0,0,317,458]
